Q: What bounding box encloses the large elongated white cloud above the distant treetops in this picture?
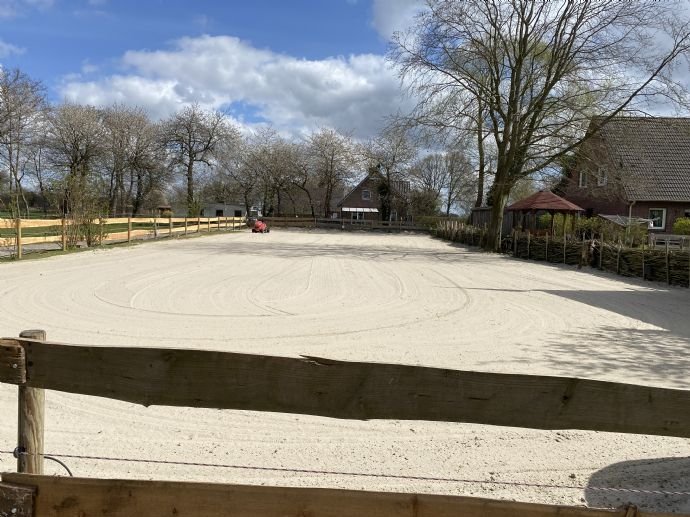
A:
[62,36,403,136]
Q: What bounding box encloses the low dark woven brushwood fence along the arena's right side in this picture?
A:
[434,222,690,287]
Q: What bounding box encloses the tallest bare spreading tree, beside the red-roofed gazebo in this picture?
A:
[390,0,690,250]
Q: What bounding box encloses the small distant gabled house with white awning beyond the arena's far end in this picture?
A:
[338,170,410,221]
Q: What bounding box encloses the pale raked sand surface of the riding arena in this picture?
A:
[0,230,690,513]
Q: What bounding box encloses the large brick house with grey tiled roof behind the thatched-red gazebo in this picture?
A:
[559,117,690,233]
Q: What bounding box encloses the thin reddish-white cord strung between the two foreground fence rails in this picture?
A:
[0,450,690,496]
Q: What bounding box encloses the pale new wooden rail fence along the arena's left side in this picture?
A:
[0,217,246,259]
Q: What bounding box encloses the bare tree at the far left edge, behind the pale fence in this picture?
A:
[0,69,46,216]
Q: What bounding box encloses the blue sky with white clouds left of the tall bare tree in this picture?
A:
[0,0,420,136]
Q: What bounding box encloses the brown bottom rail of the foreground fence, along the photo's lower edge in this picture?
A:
[0,474,682,517]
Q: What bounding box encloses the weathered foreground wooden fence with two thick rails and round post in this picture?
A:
[0,331,690,517]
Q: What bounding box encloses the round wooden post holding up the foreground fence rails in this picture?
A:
[17,330,46,474]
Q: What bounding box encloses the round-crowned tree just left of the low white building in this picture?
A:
[163,104,226,217]
